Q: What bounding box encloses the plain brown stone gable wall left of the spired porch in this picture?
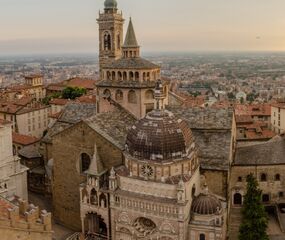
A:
[53,122,122,230]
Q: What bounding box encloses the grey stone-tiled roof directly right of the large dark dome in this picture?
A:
[166,106,233,170]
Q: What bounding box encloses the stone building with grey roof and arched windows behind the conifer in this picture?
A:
[228,137,285,240]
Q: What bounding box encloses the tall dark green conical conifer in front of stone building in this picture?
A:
[239,174,269,240]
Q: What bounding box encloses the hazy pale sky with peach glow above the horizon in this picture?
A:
[0,0,285,55]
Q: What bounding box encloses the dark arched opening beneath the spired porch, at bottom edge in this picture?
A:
[84,213,108,240]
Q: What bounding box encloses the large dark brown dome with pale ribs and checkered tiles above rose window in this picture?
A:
[126,110,194,162]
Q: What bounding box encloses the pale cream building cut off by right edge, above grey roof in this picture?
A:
[271,101,285,134]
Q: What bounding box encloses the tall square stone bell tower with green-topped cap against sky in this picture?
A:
[97,0,125,77]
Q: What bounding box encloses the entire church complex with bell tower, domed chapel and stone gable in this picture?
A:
[48,0,234,240]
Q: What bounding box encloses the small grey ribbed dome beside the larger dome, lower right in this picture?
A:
[191,193,222,215]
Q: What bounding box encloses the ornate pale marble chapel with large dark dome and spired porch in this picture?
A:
[80,84,226,240]
